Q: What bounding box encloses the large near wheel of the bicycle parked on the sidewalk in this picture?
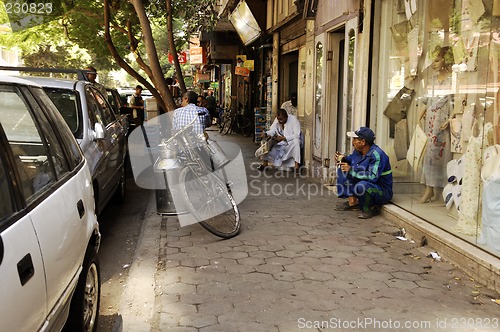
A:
[179,167,241,239]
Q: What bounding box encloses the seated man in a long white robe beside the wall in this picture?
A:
[258,109,301,173]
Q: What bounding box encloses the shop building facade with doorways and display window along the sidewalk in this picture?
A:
[212,0,500,288]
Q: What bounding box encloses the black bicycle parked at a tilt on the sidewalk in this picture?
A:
[155,118,241,239]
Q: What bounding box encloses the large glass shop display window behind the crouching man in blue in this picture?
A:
[375,0,500,256]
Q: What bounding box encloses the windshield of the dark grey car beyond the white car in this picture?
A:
[44,87,83,138]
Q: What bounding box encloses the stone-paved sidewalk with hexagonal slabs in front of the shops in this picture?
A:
[124,131,500,332]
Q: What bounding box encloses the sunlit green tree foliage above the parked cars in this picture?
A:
[0,0,217,87]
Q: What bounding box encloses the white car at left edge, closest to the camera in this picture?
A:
[0,75,101,332]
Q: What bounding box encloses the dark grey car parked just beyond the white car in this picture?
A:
[19,76,128,215]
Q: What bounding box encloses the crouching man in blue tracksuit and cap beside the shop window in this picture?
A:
[335,127,392,219]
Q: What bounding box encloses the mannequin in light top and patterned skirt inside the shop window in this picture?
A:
[419,46,453,203]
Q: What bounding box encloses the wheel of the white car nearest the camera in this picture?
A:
[64,248,101,332]
